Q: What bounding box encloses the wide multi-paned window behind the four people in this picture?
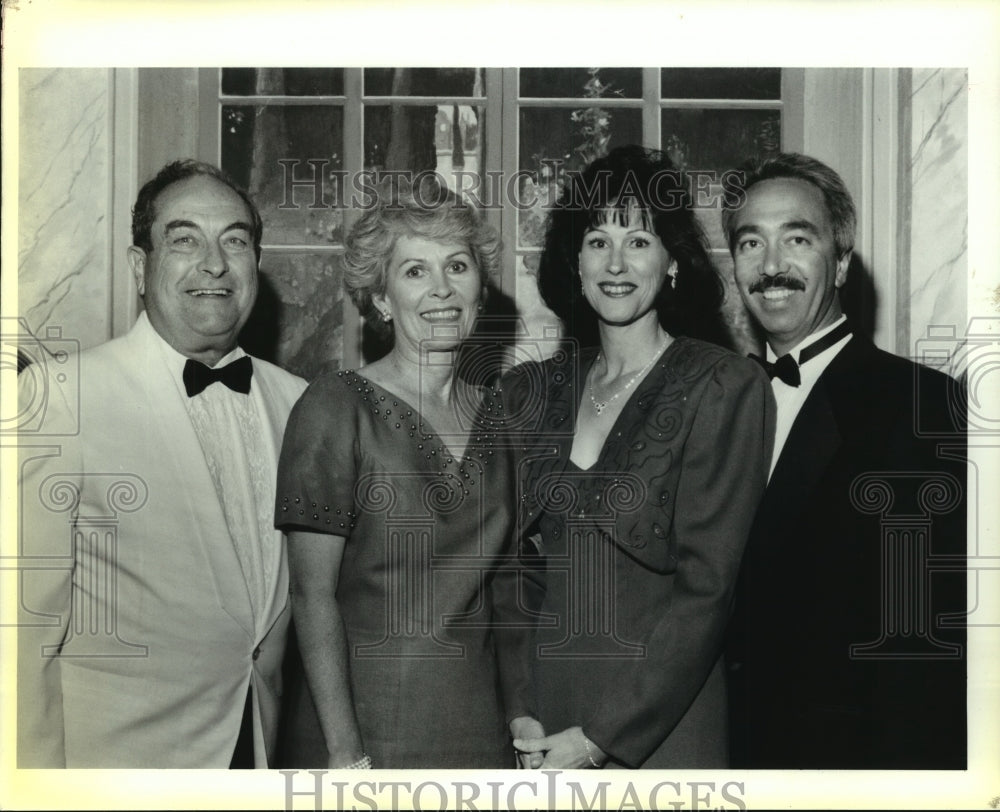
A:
[201,68,789,377]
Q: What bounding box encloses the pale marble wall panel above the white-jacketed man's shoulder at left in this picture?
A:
[18,68,113,347]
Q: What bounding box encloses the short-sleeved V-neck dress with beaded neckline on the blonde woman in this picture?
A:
[275,371,516,768]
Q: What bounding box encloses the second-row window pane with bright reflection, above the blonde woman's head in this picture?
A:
[364,104,485,195]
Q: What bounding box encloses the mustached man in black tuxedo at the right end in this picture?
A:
[723,154,966,769]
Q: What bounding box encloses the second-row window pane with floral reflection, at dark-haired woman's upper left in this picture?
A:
[511,106,642,246]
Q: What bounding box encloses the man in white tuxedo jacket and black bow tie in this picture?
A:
[17,161,305,768]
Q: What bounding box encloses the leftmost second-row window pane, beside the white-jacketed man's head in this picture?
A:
[222,105,344,245]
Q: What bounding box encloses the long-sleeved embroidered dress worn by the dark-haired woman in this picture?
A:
[503,337,774,769]
